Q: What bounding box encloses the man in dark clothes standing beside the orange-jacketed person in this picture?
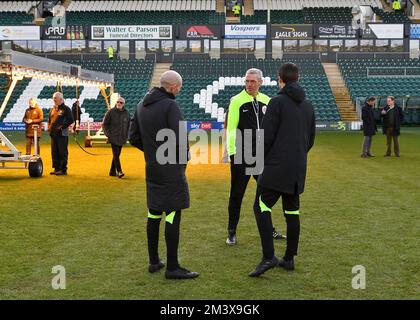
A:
[48,92,73,176]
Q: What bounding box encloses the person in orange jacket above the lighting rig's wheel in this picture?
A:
[22,98,44,155]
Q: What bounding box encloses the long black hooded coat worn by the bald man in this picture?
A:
[130,88,190,212]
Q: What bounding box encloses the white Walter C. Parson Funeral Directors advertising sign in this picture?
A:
[92,25,172,40]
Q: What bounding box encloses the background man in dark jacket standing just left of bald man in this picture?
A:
[102,97,130,178]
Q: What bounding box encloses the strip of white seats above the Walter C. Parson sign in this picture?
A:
[67,0,216,12]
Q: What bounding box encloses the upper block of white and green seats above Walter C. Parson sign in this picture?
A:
[62,0,225,25]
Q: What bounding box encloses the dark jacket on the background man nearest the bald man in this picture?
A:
[102,107,130,146]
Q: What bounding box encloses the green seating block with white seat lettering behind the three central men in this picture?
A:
[172,57,340,121]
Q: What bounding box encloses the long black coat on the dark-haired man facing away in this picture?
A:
[258,82,315,194]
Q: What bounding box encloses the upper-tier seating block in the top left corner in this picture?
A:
[0,1,37,26]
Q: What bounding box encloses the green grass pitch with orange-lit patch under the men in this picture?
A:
[0,129,420,299]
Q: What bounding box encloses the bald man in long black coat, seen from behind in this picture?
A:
[129,71,198,279]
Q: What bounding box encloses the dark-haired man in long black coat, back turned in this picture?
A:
[249,63,315,277]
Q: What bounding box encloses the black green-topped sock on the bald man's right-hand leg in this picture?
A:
[165,211,181,271]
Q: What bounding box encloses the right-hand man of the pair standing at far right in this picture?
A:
[381,96,404,157]
